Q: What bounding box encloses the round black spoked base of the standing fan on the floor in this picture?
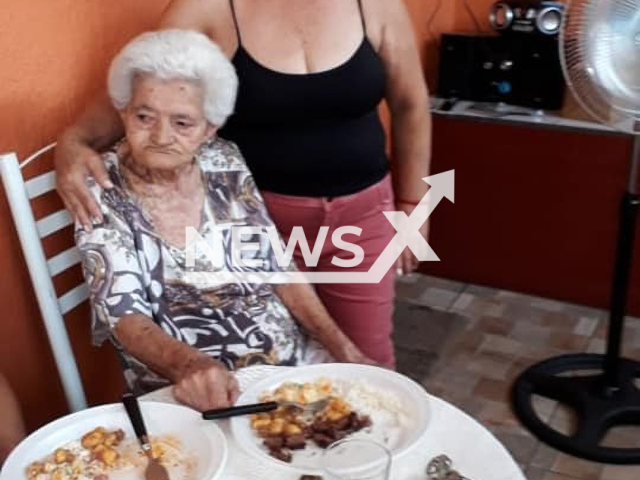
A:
[512,354,640,464]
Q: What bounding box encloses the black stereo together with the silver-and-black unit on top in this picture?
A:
[437,1,565,110]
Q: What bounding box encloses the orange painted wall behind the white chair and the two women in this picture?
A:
[0,0,454,429]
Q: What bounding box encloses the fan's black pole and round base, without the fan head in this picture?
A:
[512,136,640,464]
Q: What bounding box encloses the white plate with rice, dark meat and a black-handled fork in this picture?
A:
[231,363,430,474]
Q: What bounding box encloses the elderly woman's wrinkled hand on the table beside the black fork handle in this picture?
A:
[173,360,240,411]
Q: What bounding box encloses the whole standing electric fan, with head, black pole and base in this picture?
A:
[513,0,640,464]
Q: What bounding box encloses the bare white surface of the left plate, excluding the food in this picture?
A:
[0,401,227,480]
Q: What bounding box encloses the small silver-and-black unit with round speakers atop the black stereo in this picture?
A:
[489,0,564,35]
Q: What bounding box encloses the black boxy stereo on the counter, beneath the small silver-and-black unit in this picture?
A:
[437,34,564,110]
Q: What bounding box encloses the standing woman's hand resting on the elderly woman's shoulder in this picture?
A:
[55,132,113,230]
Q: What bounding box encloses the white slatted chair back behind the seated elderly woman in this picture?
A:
[0,144,89,411]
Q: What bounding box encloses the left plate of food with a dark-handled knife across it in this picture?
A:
[0,401,228,480]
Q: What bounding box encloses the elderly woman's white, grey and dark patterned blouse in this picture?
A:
[76,139,329,391]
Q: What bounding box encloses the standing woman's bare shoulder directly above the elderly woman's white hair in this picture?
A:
[160,0,236,55]
